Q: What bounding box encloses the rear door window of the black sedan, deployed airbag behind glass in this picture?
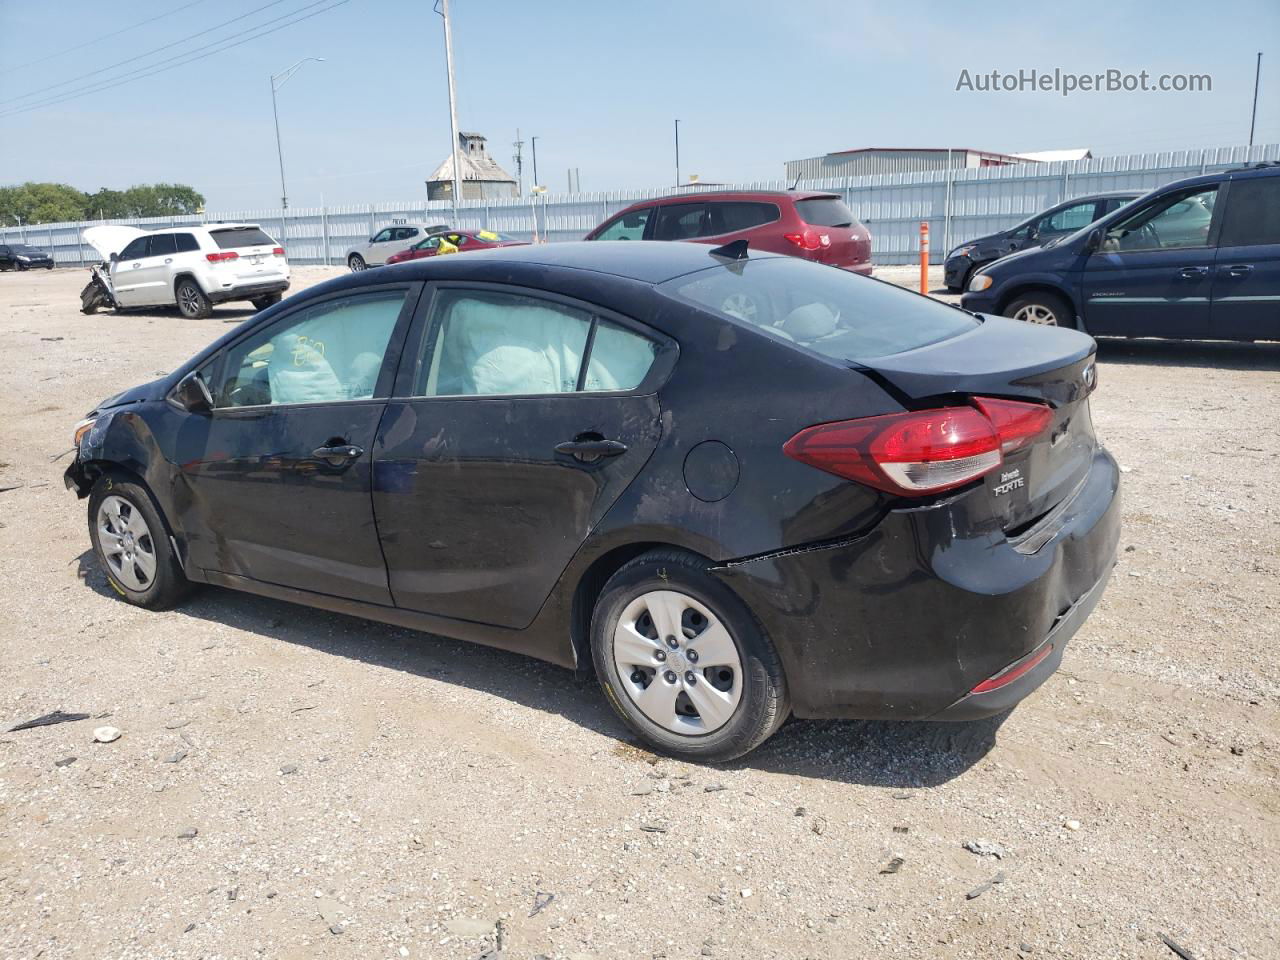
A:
[415,291,657,397]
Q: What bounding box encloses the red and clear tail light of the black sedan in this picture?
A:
[782,397,1053,497]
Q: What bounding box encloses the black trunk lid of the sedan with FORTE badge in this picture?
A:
[860,317,1097,536]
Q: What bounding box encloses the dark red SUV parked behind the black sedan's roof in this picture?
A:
[586,191,872,276]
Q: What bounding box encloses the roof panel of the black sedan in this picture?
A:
[366,241,780,283]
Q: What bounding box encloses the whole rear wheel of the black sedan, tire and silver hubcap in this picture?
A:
[591,550,791,762]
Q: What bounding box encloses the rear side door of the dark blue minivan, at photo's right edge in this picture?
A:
[1212,174,1280,340]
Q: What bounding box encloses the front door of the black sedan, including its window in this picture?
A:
[178,284,420,604]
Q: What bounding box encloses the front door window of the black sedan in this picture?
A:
[211,291,406,407]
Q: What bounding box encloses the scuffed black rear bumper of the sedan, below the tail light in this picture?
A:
[714,449,1120,719]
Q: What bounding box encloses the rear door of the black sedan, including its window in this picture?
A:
[374,285,675,627]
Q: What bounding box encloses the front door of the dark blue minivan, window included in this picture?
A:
[1080,183,1217,338]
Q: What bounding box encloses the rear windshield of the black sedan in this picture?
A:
[658,257,978,361]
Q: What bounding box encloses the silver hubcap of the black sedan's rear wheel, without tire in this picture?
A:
[613,590,742,736]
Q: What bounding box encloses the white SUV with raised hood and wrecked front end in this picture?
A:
[84,223,289,320]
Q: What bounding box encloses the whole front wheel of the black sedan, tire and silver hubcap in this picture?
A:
[88,474,191,611]
